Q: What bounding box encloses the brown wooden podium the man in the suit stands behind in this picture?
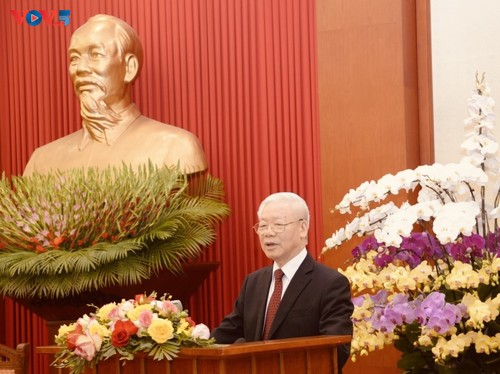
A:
[36,336,351,374]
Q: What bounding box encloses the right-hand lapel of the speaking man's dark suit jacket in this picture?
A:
[268,254,314,338]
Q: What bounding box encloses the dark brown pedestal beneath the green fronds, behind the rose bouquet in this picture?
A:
[14,262,219,344]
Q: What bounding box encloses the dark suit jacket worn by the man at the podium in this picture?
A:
[212,254,353,367]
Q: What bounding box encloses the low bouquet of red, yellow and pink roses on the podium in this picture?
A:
[52,293,214,374]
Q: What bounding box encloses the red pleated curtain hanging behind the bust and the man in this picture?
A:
[0,0,324,373]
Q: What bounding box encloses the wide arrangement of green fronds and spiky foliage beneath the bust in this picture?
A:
[0,164,229,299]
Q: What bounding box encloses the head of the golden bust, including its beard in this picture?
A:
[68,14,143,136]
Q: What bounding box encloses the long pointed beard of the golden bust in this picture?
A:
[80,80,121,144]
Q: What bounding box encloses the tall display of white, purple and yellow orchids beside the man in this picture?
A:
[324,75,500,373]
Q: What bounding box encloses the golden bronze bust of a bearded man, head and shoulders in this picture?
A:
[24,15,207,175]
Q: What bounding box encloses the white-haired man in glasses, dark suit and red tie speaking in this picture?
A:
[212,192,353,369]
